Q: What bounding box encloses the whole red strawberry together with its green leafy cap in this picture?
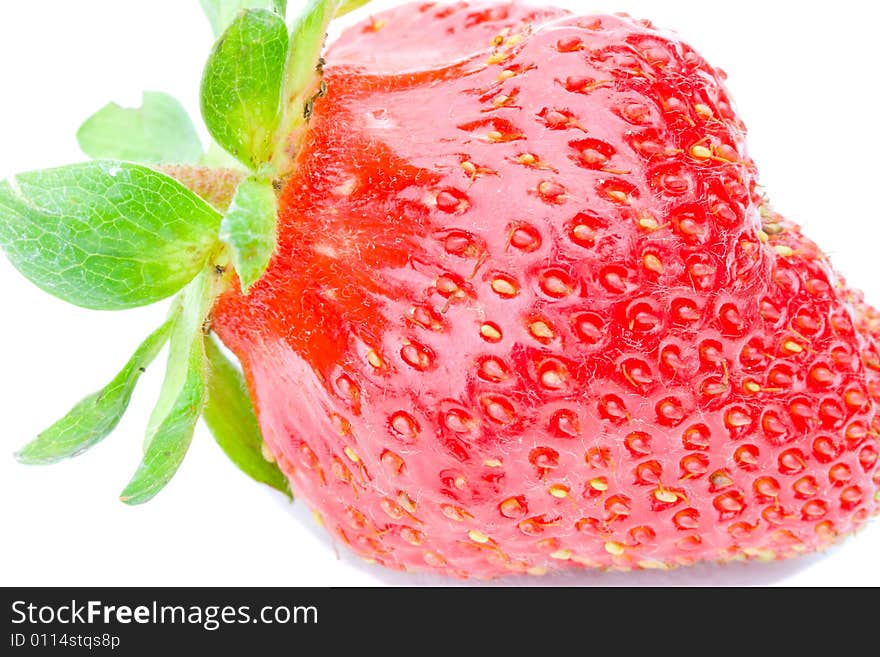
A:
[0,0,880,577]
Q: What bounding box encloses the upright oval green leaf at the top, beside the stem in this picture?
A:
[201,9,288,171]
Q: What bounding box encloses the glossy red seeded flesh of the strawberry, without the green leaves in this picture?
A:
[213,3,880,578]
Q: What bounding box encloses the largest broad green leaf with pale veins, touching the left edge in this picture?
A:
[0,160,221,310]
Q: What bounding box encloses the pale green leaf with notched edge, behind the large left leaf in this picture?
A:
[76,91,202,164]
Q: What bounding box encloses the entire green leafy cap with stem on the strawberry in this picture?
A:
[0,0,367,504]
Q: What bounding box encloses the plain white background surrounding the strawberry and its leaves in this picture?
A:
[0,0,880,586]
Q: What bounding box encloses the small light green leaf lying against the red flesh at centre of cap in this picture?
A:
[220,176,278,292]
